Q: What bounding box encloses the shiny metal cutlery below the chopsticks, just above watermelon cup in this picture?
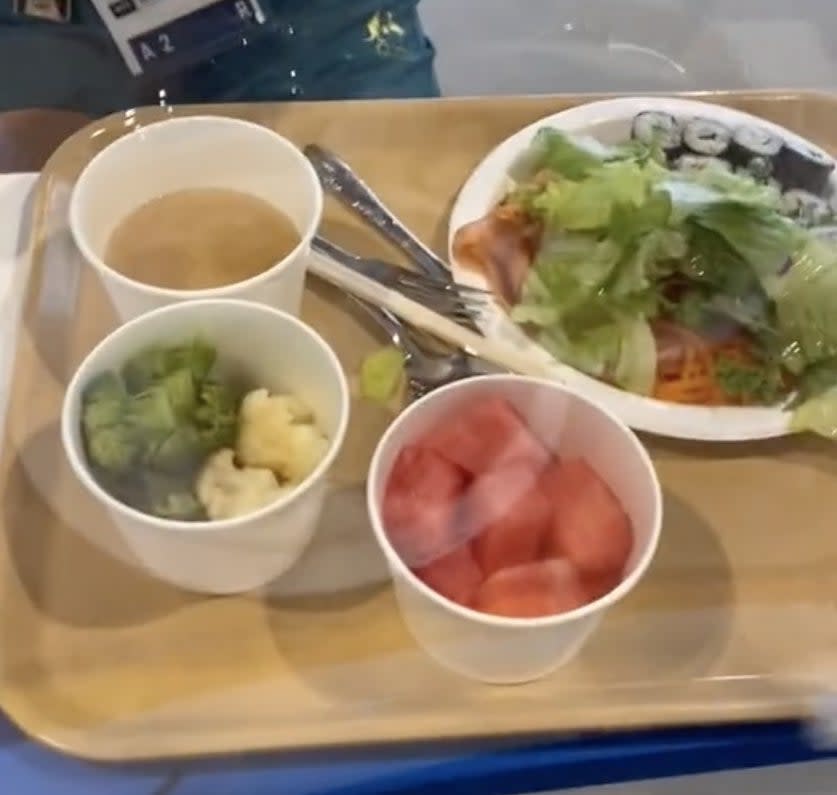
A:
[348,294,508,400]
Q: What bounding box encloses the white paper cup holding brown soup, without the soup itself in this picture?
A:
[70,116,323,321]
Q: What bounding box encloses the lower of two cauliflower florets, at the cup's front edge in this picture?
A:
[195,449,289,520]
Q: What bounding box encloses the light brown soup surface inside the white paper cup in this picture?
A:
[105,188,300,290]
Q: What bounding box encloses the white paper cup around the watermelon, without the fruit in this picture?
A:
[367,375,662,684]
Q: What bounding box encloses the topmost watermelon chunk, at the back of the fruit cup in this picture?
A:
[424,397,550,475]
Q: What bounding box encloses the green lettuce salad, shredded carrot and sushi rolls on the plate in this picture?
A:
[453,112,837,435]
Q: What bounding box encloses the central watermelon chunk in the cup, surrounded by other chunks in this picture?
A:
[465,462,553,576]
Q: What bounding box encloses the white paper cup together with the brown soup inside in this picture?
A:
[70,116,323,321]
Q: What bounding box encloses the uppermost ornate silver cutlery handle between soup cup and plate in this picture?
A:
[304,144,453,284]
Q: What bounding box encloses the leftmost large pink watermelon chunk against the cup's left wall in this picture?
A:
[382,445,467,568]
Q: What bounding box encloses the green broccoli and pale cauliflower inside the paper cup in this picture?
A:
[81,339,328,521]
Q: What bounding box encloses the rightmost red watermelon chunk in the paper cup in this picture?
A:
[541,459,633,575]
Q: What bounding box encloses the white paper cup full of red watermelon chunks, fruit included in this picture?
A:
[367,375,662,684]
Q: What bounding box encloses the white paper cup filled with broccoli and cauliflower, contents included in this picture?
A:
[61,299,349,593]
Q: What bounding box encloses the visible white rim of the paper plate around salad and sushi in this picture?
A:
[448,97,837,442]
